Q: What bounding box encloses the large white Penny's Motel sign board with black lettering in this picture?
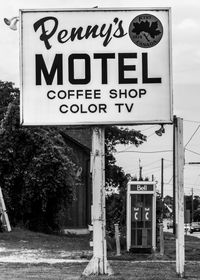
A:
[20,8,172,125]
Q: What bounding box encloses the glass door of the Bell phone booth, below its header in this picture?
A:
[130,194,153,248]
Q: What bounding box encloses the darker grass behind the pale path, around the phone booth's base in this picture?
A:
[0,228,200,261]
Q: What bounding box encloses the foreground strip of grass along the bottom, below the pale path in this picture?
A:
[0,261,200,280]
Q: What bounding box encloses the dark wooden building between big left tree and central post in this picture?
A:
[62,128,92,234]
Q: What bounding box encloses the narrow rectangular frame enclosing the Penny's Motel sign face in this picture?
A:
[20,7,173,126]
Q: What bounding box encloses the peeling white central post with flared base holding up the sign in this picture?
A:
[83,127,113,276]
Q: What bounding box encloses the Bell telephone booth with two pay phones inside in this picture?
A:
[127,181,156,252]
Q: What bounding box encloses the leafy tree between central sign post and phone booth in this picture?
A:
[105,126,146,232]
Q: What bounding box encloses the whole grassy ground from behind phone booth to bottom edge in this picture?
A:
[0,229,200,280]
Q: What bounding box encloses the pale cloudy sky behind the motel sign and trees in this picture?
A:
[0,0,200,195]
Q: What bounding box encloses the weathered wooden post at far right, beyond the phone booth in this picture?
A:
[174,117,185,277]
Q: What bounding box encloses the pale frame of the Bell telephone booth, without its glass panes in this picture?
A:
[127,181,156,252]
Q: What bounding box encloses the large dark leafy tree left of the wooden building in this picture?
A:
[0,82,76,231]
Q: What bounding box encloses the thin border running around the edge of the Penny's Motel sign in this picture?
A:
[19,7,173,126]
